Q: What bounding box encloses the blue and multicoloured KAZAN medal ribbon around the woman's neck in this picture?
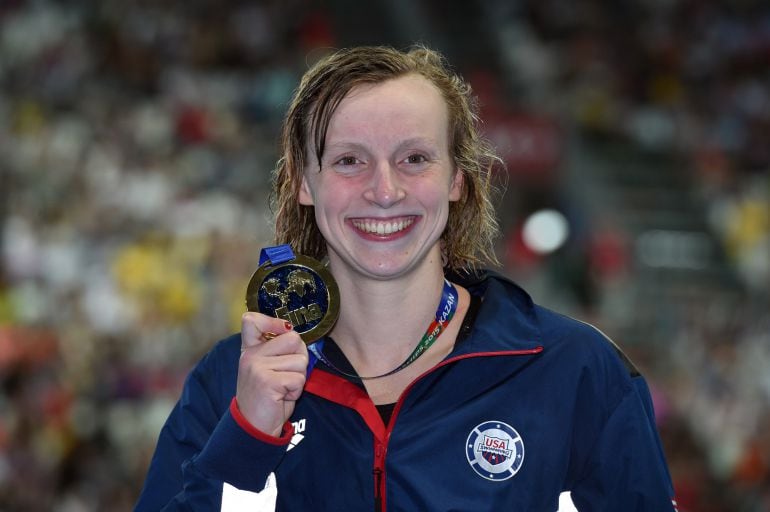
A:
[308,279,458,380]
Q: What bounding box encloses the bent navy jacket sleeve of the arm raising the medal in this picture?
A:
[135,340,292,512]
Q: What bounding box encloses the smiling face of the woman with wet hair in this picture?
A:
[299,75,462,279]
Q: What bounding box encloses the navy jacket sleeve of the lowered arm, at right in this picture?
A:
[570,368,676,512]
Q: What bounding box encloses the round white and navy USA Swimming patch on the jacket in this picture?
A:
[465,421,524,481]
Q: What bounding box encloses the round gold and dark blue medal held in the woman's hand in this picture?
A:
[246,256,340,344]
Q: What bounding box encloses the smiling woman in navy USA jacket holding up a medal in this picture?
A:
[137,47,674,511]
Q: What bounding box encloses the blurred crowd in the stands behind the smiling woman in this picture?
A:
[0,0,770,512]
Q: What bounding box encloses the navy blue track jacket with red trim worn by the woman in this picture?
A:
[136,273,675,512]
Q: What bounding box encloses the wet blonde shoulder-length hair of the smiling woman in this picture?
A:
[272,46,502,270]
